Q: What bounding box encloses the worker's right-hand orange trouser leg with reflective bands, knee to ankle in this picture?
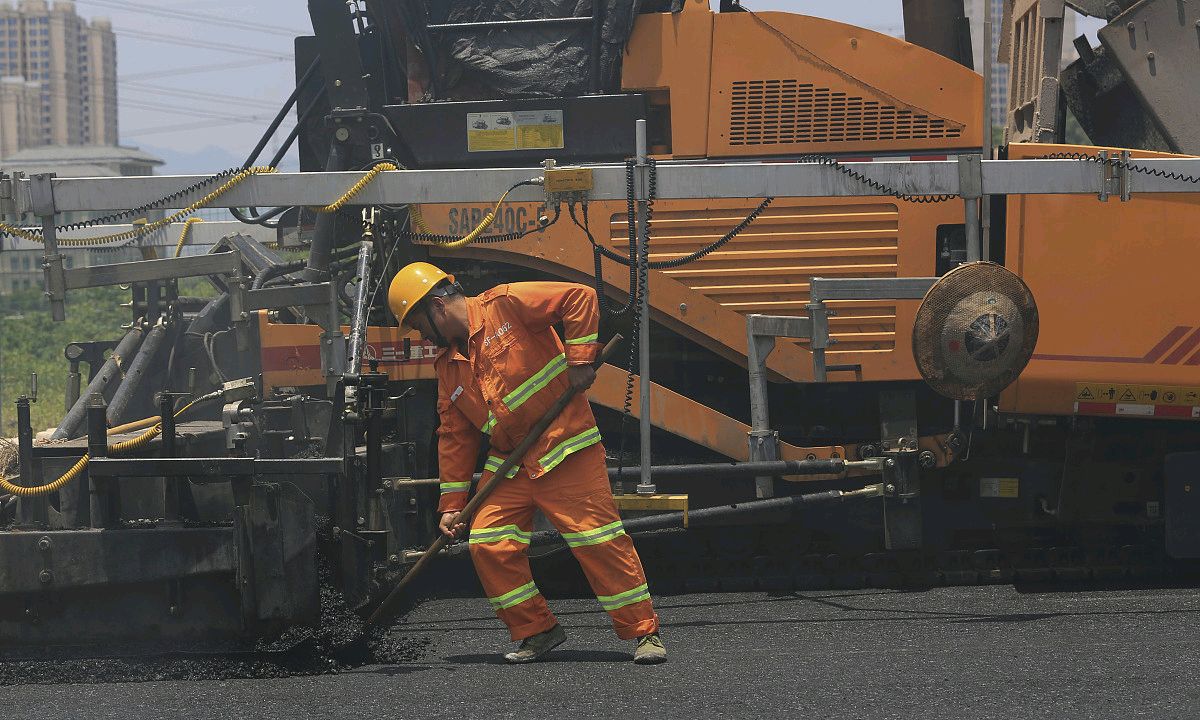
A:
[533,444,659,638]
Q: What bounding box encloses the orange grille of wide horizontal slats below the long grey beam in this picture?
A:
[608,198,900,353]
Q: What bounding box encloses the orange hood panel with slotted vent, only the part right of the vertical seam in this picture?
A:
[705,12,983,157]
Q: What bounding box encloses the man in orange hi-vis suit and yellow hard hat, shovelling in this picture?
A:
[388,263,666,664]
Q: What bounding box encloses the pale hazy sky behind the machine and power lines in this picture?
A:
[76,0,1094,173]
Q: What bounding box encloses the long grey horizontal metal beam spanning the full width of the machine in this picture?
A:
[14,158,1200,212]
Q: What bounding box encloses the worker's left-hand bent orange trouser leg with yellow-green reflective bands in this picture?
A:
[469,473,558,640]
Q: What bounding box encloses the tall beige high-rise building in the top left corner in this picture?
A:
[0,0,118,151]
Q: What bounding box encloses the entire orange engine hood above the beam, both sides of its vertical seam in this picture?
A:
[622,0,983,157]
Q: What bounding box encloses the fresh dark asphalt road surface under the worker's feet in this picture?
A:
[0,586,1200,720]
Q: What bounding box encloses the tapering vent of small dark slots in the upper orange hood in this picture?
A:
[730,80,962,145]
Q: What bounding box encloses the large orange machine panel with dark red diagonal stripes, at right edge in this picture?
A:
[1000,144,1200,419]
